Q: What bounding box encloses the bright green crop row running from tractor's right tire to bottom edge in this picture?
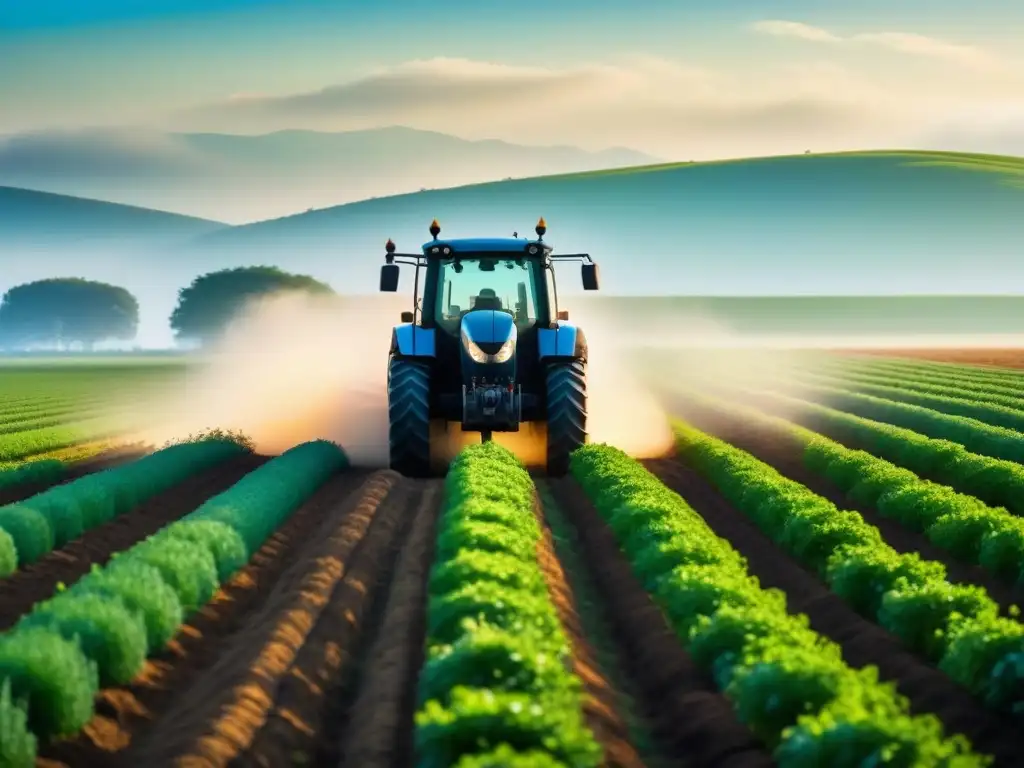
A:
[571,445,990,768]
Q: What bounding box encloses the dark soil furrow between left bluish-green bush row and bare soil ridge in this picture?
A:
[40,471,383,768]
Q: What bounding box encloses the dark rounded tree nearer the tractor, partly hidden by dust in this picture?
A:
[171,266,334,342]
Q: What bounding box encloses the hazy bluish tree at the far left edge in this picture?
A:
[0,278,138,349]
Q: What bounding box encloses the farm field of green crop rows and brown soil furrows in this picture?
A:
[0,353,1024,768]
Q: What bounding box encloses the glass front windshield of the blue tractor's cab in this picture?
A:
[435,258,541,334]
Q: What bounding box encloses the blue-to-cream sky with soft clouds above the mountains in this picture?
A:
[0,0,1024,160]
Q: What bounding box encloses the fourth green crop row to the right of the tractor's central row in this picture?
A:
[758,392,1024,515]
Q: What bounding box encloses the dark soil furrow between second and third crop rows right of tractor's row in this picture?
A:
[671,407,1024,613]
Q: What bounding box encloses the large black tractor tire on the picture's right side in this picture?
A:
[548,360,587,477]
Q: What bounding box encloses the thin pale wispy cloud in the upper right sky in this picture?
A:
[751,19,1002,70]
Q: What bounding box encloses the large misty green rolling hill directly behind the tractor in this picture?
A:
[189,152,1024,296]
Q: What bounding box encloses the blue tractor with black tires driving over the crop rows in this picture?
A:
[380,218,599,477]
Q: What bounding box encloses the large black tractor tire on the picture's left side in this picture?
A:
[387,357,430,477]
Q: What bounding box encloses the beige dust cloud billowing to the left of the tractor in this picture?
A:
[134,293,398,467]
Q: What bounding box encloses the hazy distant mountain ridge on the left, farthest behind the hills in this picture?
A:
[0,127,658,222]
